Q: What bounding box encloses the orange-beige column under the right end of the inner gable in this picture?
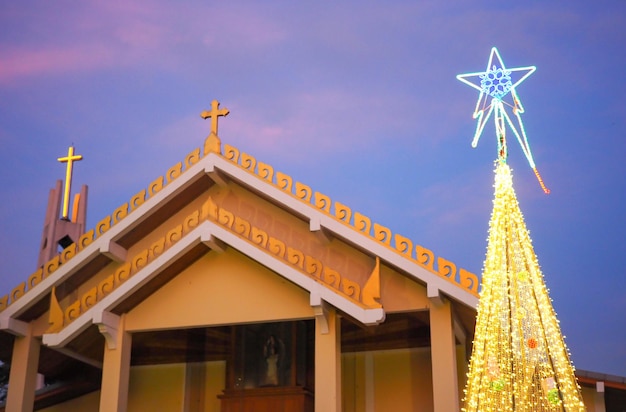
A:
[315,308,341,412]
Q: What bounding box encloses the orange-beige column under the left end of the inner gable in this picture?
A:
[99,315,132,412]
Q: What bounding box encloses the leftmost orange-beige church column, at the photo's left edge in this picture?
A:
[6,327,41,412]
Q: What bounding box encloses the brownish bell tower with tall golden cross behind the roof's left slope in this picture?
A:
[37,146,87,267]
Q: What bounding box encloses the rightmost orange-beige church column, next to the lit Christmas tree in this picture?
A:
[430,298,460,412]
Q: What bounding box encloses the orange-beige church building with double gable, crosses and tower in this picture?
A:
[0,101,626,412]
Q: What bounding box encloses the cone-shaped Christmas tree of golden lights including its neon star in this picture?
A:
[458,48,585,412]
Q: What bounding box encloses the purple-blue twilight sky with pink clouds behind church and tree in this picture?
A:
[0,0,626,376]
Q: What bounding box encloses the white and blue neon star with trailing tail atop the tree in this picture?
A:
[456,47,550,193]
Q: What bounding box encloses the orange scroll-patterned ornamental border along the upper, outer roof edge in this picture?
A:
[0,133,479,313]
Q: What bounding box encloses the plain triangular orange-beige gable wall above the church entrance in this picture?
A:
[126,248,313,331]
